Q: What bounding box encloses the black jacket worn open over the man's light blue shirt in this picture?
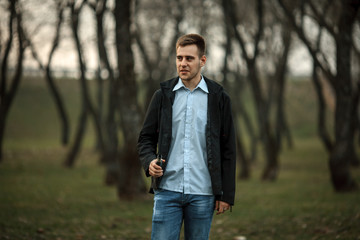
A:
[138,77,236,205]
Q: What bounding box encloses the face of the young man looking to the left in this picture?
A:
[176,44,206,81]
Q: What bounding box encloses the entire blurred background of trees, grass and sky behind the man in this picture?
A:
[0,0,360,239]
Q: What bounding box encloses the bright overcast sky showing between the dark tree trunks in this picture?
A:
[0,0,312,75]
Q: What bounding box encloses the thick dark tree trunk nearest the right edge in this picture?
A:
[329,0,359,192]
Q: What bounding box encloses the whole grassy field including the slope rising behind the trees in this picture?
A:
[0,76,360,240]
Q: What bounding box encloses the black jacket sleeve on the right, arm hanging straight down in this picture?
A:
[220,92,236,205]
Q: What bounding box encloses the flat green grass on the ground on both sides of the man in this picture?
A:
[0,139,360,240]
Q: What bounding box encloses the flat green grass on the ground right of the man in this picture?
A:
[225,139,360,239]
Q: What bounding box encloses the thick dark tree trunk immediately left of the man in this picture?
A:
[114,0,145,198]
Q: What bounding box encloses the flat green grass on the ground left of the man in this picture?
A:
[0,149,152,239]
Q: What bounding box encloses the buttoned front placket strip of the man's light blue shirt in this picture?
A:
[184,91,193,193]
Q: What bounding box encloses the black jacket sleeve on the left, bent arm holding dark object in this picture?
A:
[137,89,161,177]
